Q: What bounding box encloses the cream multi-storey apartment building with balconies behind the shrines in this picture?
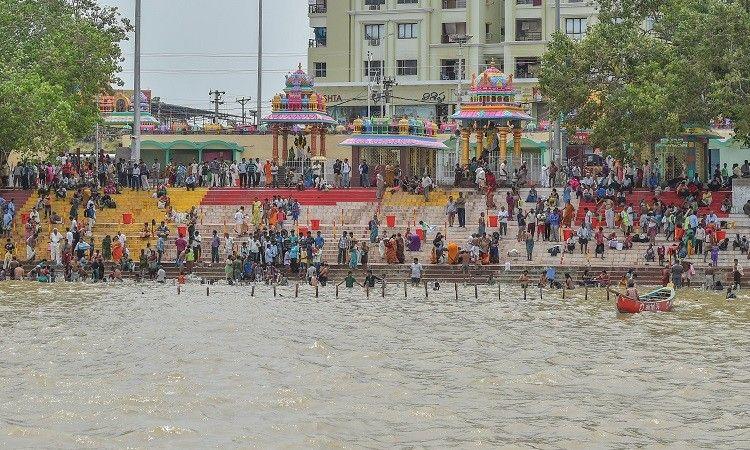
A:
[308,0,595,121]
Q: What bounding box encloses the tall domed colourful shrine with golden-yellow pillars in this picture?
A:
[451,62,533,165]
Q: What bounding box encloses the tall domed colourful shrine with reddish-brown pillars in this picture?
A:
[262,64,336,161]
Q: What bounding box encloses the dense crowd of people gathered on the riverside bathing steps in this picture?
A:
[0,154,750,283]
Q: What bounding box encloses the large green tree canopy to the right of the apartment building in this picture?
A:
[539,0,750,153]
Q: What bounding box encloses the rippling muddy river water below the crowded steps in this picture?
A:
[0,283,750,448]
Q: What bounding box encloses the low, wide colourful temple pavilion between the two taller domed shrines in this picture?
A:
[339,117,448,183]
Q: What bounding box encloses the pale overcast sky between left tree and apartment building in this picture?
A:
[99,0,311,115]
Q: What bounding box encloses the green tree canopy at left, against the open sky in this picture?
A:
[0,0,131,163]
